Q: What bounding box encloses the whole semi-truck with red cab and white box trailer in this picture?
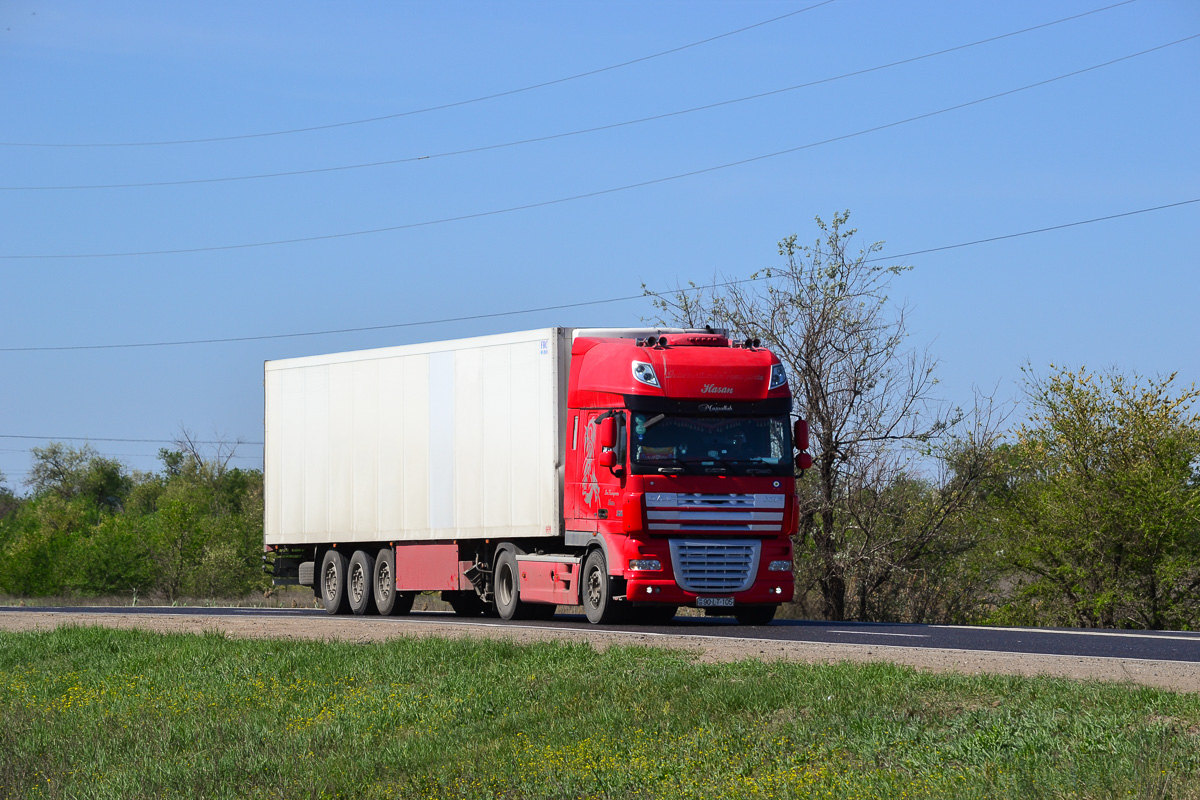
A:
[264,327,811,624]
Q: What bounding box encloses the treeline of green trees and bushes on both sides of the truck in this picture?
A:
[0,366,1200,630]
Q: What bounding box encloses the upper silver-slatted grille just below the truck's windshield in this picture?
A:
[646,492,784,534]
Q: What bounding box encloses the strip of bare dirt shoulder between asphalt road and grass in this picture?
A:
[0,609,1200,692]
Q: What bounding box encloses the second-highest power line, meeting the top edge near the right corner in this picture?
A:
[0,0,1138,192]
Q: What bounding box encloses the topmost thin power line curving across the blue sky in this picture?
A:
[0,0,836,148]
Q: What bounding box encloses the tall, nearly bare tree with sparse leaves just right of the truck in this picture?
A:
[647,211,997,620]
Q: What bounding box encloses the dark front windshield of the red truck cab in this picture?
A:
[629,413,792,476]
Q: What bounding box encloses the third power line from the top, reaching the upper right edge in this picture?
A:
[7,34,1200,260]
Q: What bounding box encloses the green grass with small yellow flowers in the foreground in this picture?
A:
[0,621,1200,799]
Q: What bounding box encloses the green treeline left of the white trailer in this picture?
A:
[0,437,262,601]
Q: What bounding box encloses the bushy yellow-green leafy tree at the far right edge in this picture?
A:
[998,365,1200,628]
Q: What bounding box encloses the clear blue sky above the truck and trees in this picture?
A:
[0,0,1200,491]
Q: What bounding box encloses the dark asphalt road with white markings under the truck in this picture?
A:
[11,606,1200,663]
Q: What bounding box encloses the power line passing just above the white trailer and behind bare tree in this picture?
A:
[0,198,1200,352]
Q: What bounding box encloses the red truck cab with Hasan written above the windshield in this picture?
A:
[564,332,810,624]
